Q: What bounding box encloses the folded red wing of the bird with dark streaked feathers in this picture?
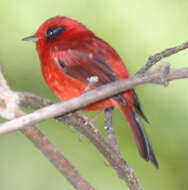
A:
[56,49,126,105]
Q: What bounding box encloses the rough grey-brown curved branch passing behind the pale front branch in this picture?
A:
[17,92,142,190]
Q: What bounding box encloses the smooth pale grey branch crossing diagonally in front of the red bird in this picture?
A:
[0,63,188,134]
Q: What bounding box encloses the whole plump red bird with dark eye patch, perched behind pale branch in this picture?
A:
[24,16,158,168]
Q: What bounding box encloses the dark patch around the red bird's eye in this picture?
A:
[45,26,65,42]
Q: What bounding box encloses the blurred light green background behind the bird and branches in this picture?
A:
[0,0,188,190]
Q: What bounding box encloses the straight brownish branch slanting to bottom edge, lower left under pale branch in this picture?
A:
[21,126,95,190]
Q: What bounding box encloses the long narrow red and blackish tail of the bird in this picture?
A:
[120,105,158,168]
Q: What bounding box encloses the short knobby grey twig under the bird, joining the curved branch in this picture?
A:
[104,107,120,154]
